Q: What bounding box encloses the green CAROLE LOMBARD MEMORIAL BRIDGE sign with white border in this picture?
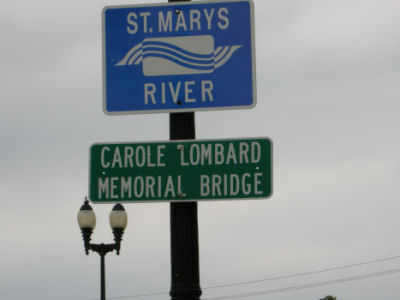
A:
[89,138,272,203]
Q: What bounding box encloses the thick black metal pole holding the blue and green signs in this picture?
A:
[168,0,201,300]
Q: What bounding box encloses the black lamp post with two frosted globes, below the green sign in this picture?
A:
[78,199,128,300]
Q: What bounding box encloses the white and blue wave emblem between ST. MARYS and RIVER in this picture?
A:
[115,35,242,76]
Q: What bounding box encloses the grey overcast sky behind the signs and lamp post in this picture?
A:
[0,0,400,300]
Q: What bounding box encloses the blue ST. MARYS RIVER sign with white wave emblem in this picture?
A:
[103,0,256,114]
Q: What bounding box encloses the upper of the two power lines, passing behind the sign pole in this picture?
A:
[108,255,400,300]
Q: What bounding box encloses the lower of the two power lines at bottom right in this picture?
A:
[203,268,400,300]
